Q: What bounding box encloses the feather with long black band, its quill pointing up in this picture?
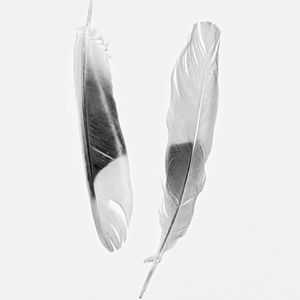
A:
[74,1,132,251]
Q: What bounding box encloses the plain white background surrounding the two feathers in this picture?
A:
[0,0,300,300]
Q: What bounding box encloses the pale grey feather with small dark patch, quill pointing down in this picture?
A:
[140,22,220,298]
